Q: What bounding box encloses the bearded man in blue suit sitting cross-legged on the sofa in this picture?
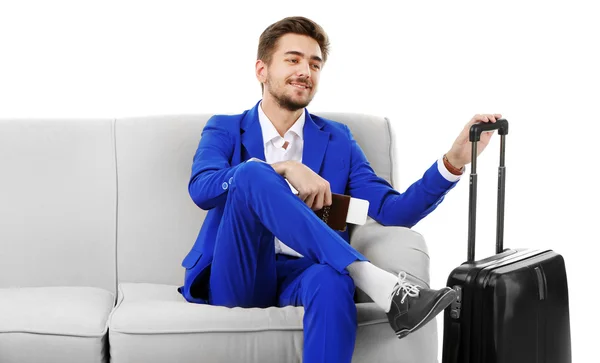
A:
[180,17,501,362]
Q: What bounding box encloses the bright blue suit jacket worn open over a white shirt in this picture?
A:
[178,101,456,303]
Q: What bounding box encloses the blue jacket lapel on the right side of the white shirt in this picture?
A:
[302,109,329,174]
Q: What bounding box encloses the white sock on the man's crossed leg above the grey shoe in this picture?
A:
[346,261,398,313]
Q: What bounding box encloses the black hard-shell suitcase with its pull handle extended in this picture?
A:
[442,119,571,363]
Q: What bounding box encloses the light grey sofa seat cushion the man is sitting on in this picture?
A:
[109,283,437,363]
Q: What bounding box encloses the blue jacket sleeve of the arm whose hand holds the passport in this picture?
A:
[188,116,247,210]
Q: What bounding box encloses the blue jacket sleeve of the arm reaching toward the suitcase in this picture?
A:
[346,127,457,228]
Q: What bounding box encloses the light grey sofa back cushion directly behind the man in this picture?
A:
[116,112,395,285]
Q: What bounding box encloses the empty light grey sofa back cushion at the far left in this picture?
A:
[0,119,117,292]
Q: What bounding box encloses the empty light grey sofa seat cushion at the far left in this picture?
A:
[0,287,115,363]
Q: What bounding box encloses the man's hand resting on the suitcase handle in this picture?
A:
[446,113,502,169]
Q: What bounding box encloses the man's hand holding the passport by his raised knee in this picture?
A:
[272,160,331,211]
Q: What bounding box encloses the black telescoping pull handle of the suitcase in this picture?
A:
[467,118,508,262]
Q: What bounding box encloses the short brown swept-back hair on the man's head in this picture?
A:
[257,16,329,94]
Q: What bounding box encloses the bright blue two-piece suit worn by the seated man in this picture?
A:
[179,102,456,362]
